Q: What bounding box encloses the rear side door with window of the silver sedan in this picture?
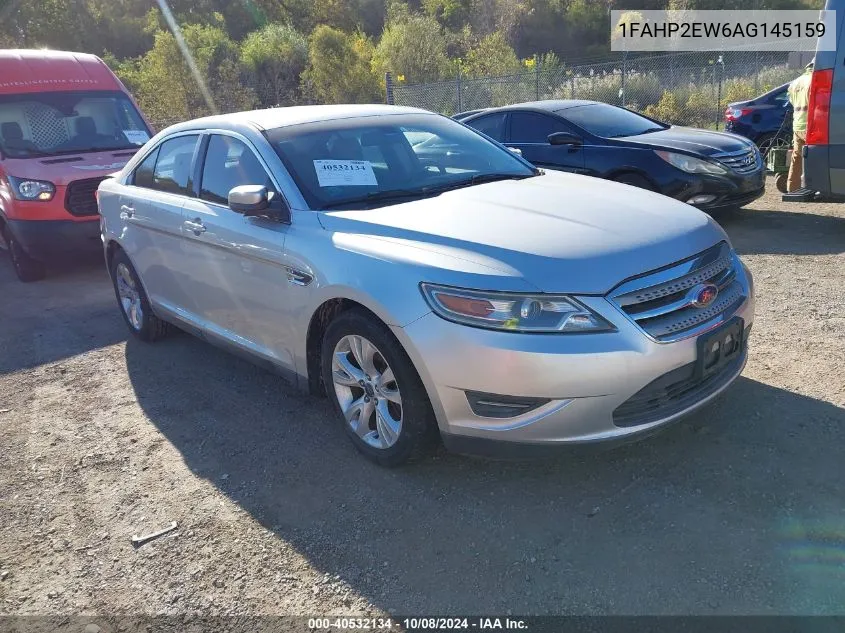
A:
[120,134,199,312]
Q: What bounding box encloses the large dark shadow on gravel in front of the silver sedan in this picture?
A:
[126,336,845,614]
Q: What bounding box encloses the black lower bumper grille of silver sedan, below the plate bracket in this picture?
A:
[613,344,750,427]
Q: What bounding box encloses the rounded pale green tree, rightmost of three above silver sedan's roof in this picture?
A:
[373,14,450,83]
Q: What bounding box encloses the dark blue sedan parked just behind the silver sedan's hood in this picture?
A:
[462,100,765,211]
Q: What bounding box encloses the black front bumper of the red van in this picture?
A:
[6,216,103,260]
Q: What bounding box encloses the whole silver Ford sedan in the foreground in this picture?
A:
[99,105,754,466]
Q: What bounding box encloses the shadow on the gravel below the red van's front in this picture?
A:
[0,251,127,375]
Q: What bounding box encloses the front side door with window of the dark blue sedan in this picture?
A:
[508,111,584,173]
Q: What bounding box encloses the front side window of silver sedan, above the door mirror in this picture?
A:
[200,134,273,204]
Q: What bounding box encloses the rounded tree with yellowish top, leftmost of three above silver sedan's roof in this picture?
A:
[241,23,308,106]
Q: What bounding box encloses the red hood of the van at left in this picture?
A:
[3,149,137,185]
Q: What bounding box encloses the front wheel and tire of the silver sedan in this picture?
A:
[321,310,438,467]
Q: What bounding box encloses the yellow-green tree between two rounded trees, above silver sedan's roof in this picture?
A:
[302,25,384,103]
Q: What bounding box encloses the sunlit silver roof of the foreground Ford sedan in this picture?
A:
[164,104,436,134]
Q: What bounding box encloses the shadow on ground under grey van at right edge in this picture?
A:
[713,204,845,255]
